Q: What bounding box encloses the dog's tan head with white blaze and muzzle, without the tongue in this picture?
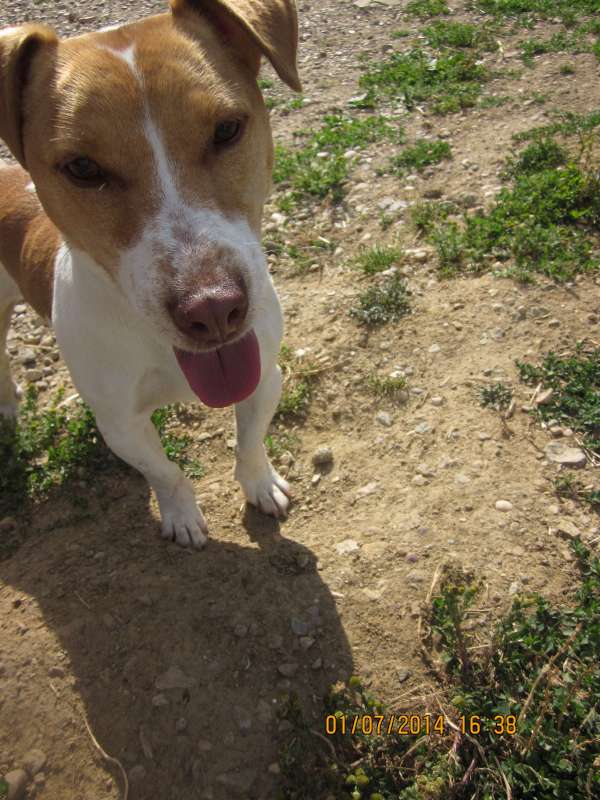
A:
[0,0,300,406]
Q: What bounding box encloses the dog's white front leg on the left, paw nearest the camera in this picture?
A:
[96,411,208,548]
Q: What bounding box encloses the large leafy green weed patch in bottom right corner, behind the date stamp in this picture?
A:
[277,541,600,800]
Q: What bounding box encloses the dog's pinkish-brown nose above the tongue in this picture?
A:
[169,283,248,347]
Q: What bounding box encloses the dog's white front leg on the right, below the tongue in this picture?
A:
[234,364,290,517]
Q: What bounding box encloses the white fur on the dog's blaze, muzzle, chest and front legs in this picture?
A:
[0,0,300,547]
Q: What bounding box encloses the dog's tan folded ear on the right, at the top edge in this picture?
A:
[170,0,302,92]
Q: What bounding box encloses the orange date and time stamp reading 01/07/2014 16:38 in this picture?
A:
[325,712,517,736]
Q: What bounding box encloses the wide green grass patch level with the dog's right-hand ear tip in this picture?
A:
[359,48,489,114]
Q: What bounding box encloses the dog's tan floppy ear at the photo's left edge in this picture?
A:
[0,24,58,168]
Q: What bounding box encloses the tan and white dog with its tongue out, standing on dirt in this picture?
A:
[0,0,301,547]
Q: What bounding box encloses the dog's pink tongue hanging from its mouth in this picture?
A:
[173,331,260,408]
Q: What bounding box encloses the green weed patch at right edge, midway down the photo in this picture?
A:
[517,342,600,457]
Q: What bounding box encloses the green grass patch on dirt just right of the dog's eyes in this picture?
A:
[273,114,403,202]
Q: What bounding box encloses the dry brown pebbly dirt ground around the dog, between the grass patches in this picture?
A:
[0,0,600,800]
